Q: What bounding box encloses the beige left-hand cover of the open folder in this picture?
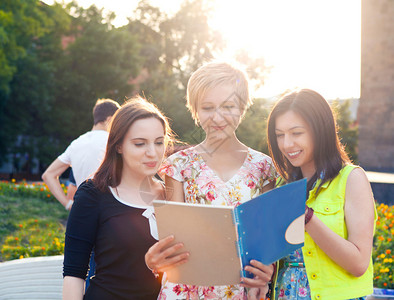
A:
[154,201,241,286]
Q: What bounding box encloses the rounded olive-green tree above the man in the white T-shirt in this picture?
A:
[52,3,141,143]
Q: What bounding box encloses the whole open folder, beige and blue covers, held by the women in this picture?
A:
[153,179,306,286]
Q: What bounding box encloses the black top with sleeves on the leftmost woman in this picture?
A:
[63,180,160,300]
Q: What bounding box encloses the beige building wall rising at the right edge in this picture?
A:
[358,0,394,203]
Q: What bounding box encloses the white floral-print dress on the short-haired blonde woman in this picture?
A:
[158,147,277,300]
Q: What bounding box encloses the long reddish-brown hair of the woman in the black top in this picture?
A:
[93,96,173,192]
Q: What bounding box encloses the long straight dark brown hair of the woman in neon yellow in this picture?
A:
[267,89,350,190]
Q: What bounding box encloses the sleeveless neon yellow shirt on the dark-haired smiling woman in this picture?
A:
[272,165,377,300]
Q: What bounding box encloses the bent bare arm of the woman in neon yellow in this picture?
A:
[305,168,374,277]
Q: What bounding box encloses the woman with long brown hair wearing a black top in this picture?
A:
[63,97,171,300]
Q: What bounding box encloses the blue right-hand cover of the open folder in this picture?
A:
[234,179,306,277]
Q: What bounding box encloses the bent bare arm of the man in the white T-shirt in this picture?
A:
[42,158,69,207]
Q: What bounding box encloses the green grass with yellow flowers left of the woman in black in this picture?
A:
[0,186,68,261]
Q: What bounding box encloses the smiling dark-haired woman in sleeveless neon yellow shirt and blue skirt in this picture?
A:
[268,89,375,300]
